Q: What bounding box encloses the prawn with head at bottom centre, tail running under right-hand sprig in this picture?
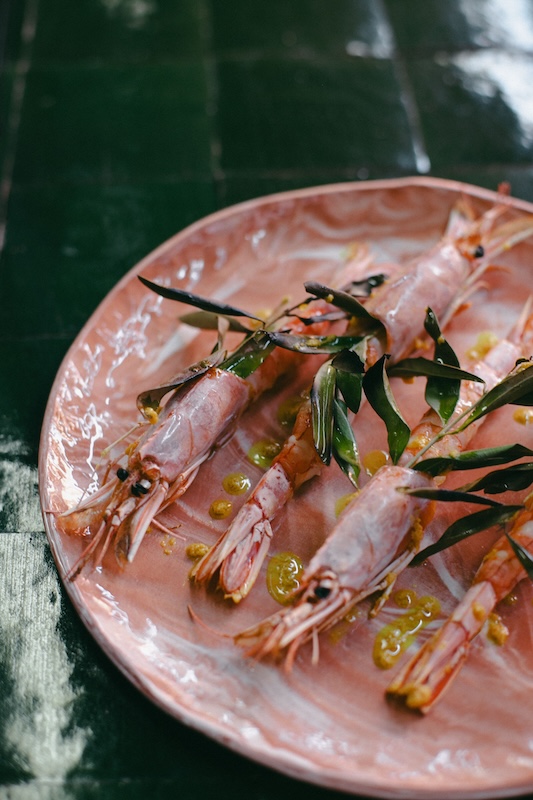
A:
[236,316,533,668]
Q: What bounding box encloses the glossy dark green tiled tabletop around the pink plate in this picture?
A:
[0,0,533,800]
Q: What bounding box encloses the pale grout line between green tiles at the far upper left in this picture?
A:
[0,0,39,252]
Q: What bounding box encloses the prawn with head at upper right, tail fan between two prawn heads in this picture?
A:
[191,197,533,602]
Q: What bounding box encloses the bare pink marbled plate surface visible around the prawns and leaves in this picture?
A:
[40,178,533,800]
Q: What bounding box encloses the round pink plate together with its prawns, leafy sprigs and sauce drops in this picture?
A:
[39,178,533,800]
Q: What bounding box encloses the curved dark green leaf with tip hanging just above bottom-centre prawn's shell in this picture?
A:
[363,355,410,464]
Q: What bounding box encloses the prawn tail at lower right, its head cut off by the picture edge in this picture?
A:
[387,494,533,713]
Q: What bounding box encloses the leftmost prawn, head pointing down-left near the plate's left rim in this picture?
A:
[59,247,370,579]
